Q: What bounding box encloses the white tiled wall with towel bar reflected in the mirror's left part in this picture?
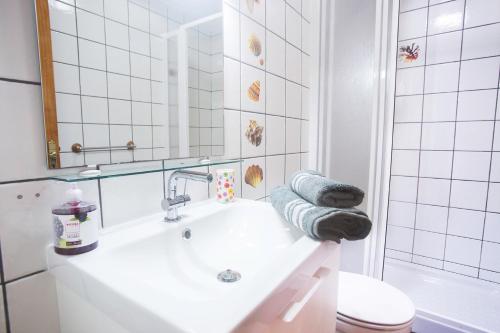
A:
[49,0,169,167]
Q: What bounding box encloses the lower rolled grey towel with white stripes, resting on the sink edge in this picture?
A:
[271,186,372,243]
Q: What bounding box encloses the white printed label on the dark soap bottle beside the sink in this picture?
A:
[53,213,98,249]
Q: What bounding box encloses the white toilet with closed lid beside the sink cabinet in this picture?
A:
[337,272,415,333]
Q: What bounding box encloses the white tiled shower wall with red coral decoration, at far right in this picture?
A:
[385,0,500,283]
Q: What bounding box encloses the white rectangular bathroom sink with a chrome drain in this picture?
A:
[48,199,336,332]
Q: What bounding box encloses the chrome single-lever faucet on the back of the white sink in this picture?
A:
[161,170,213,222]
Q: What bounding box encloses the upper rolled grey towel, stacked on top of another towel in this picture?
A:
[289,170,365,208]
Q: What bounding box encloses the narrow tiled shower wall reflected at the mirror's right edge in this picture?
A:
[188,24,224,157]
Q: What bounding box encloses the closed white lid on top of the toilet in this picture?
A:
[337,272,415,326]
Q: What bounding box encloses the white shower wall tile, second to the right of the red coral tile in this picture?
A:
[462,23,500,59]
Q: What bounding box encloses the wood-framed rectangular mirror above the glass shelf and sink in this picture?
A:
[35,0,224,169]
